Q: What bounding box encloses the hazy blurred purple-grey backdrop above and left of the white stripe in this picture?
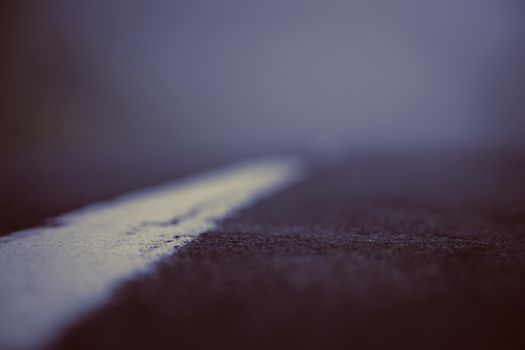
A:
[0,0,525,233]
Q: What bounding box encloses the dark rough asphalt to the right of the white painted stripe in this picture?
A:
[47,157,525,349]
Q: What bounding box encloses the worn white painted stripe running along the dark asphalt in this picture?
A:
[0,157,302,349]
